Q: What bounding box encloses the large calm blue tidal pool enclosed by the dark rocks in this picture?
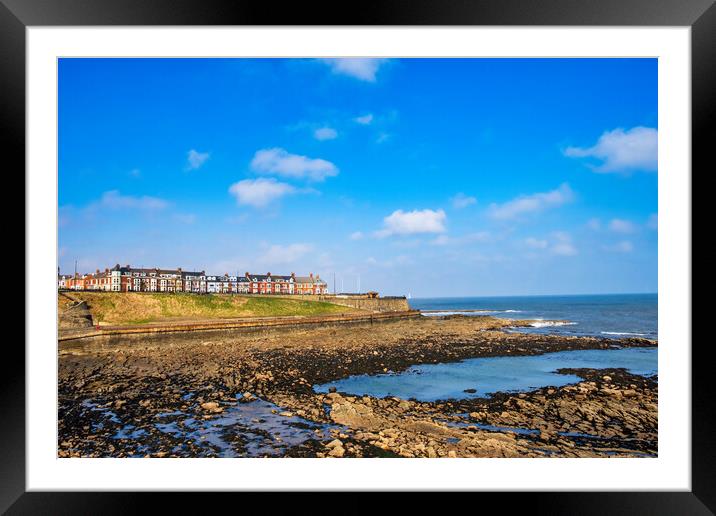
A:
[315,347,658,401]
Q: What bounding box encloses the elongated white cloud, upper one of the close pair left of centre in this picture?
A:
[251,147,338,181]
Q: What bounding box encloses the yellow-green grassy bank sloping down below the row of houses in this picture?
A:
[58,292,359,324]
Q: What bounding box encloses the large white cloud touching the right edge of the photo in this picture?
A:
[564,126,658,173]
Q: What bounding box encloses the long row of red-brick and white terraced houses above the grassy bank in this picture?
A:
[57,264,328,295]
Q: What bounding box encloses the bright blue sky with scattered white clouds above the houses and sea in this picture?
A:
[58,59,657,297]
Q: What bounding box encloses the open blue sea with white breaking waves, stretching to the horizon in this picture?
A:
[409,294,658,339]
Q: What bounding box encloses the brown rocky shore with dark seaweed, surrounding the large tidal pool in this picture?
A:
[58,316,658,457]
